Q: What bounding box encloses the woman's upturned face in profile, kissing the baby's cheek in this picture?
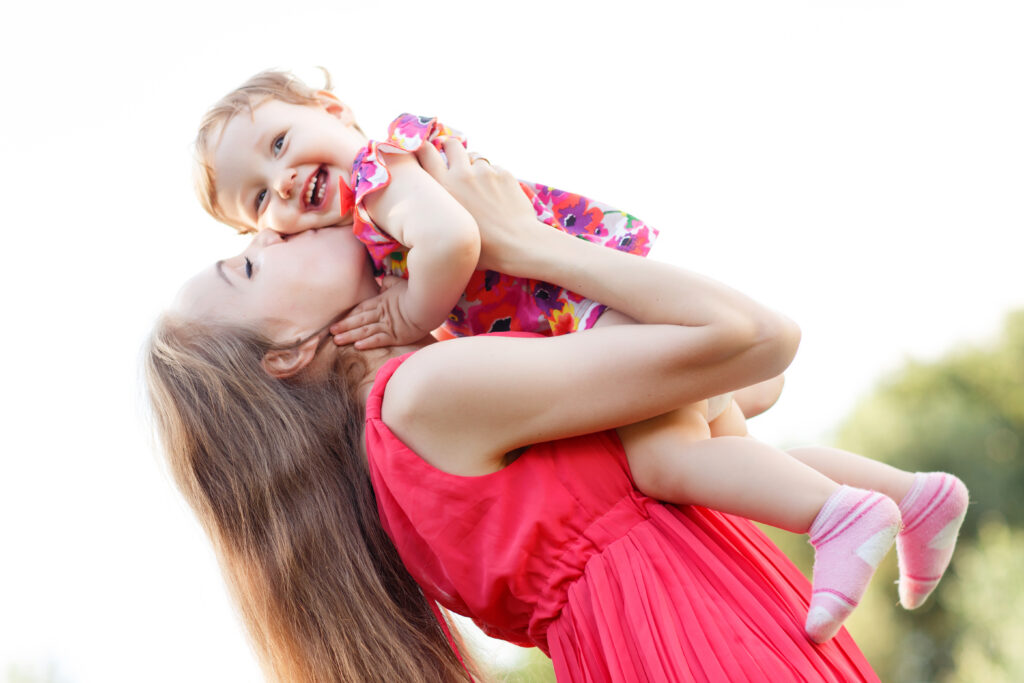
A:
[176,227,379,345]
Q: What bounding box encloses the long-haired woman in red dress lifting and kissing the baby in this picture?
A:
[147,141,874,681]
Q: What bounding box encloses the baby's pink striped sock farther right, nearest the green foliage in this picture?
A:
[896,472,968,609]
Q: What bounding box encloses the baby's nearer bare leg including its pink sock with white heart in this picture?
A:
[618,419,900,642]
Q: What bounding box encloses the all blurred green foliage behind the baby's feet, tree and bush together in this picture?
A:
[831,311,1024,683]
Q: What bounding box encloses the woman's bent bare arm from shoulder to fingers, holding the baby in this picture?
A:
[384,146,800,475]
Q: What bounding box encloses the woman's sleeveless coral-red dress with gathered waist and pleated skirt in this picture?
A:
[367,356,878,683]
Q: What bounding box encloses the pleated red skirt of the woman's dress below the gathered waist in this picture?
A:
[547,505,878,683]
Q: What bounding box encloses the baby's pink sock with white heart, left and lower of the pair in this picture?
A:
[804,486,900,643]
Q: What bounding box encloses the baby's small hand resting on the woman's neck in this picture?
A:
[331,275,430,350]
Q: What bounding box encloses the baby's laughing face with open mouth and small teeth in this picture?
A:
[212,97,367,234]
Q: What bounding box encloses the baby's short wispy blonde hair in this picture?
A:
[193,68,331,234]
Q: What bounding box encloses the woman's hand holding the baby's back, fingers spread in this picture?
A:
[416,138,552,274]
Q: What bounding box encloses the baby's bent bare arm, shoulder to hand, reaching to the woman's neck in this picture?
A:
[331,154,480,349]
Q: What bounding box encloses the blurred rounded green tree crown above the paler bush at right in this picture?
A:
[839,311,1024,541]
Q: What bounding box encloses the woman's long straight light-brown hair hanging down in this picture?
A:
[145,315,468,683]
